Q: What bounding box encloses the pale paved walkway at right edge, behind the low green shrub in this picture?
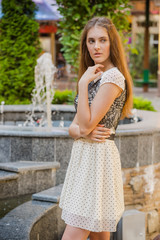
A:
[133,87,160,112]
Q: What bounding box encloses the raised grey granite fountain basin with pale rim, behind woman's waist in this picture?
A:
[0,105,160,184]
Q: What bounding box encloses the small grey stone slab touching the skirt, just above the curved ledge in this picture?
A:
[32,184,63,203]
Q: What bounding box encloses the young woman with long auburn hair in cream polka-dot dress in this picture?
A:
[60,17,132,240]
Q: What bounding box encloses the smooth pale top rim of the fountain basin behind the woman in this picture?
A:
[0,110,160,138]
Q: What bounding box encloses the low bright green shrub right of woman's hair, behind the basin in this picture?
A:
[133,97,156,112]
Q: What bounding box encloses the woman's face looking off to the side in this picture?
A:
[86,26,110,65]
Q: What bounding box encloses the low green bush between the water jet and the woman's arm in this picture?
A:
[52,89,76,104]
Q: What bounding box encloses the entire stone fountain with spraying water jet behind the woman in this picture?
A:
[0,52,160,239]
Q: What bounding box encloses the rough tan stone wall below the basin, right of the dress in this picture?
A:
[122,163,160,240]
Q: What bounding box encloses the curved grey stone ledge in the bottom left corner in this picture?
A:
[0,201,64,240]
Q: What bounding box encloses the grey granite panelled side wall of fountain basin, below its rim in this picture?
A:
[0,128,160,187]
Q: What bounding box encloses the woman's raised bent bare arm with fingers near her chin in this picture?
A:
[77,64,122,135]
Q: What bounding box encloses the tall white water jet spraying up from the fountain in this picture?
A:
[24,53,57,128]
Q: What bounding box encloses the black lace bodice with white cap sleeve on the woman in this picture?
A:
[74,67,126,133]
